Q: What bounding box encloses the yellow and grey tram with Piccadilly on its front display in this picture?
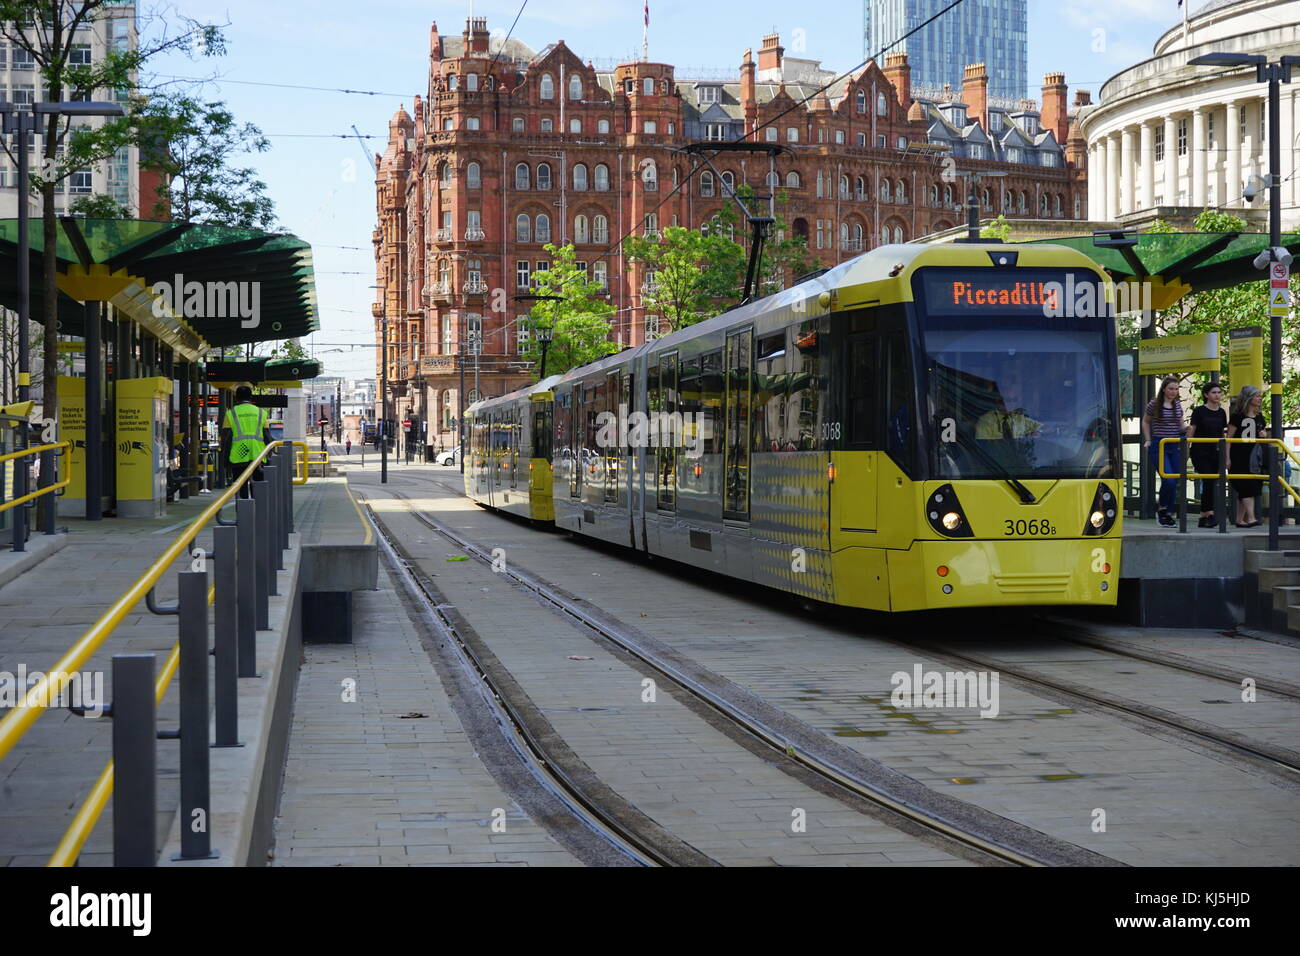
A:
[465,243,1122,611]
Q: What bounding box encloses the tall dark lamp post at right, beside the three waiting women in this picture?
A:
[1187,53,1300,551]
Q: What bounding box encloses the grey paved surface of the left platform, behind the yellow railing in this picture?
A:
[0,470,363,865]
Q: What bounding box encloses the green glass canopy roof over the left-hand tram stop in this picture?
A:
[0,217,320,346]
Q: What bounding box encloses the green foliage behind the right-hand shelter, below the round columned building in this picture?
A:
[1119,209,1300,424]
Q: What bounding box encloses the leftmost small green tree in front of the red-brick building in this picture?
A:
[523,242,619,377]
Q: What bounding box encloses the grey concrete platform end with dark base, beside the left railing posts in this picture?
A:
[294,477,380,644]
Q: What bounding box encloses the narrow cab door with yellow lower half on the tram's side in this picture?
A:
[831,334,884,531]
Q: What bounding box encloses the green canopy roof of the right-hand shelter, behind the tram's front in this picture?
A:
[1032,233,1300,293]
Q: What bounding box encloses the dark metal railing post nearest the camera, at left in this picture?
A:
[113,654,159,866]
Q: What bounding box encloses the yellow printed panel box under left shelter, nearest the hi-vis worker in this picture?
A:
[116,377,172,518]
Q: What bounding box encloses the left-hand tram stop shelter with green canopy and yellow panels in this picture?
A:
[0,217,320,531]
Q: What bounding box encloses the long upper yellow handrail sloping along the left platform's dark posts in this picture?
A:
[0,441,283,760]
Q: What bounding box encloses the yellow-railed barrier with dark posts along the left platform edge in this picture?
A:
[0,441,306,866]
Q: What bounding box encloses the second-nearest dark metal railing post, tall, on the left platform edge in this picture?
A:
[174,571,216,860]
